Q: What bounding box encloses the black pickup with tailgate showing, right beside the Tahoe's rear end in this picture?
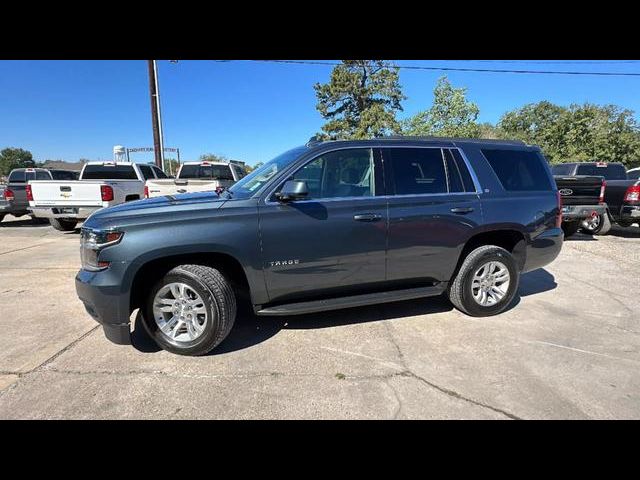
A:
[551,173,607,237]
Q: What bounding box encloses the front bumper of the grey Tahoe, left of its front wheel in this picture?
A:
[76,269,131,345]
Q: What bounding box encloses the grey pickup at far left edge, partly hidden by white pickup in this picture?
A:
[0,168,78,222]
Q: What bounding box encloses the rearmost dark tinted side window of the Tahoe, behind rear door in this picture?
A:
[482,149,552,192]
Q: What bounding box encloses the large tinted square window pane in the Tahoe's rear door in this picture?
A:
[388,148,447,195]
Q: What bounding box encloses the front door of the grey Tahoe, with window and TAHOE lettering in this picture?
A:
[259,148,387,301]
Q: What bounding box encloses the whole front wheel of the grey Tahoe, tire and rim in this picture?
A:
[143,265,236,355]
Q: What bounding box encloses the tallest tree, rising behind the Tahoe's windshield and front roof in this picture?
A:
[313,60,406,139]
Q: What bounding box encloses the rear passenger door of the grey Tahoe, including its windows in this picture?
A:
[382,147,482,283]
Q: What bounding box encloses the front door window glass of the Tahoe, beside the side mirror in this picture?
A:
[290,148,375,200]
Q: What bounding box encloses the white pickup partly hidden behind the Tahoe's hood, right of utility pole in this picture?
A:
[145,160,247,198]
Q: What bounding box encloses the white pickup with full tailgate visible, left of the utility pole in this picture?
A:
[27,162,167,231]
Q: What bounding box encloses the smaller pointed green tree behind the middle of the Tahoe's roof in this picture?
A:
[403,76,482,138]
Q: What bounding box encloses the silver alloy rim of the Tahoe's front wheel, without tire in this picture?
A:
[153,283,209,342]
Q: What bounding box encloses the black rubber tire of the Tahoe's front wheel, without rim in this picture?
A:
[143,265,237,356]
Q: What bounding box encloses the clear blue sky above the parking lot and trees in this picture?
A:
[0,60,640,164]
